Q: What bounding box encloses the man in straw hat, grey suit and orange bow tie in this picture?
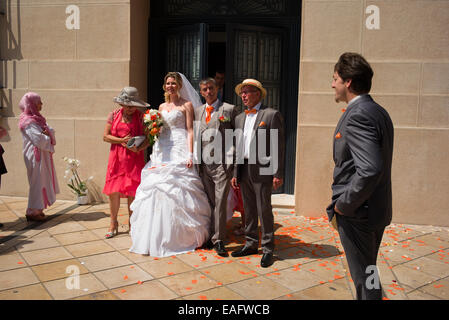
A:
[231,79,285,268]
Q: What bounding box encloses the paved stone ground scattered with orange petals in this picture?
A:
[0,197,449,300]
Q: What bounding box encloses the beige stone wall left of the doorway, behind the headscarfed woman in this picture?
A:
[0,0,149,200]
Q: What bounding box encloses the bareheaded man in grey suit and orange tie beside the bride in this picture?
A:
[195,78,237,257]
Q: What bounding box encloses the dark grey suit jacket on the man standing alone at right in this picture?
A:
[327,95,394,230]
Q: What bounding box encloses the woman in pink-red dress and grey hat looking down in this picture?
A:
[103,87,149,239]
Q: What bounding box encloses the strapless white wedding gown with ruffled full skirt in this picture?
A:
[129,110,211,257]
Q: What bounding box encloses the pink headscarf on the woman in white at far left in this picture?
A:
[19,92,54,144]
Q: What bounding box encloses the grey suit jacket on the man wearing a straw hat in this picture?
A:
[234,106,285,182]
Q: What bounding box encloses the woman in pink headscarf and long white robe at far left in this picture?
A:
[19,92,59,221]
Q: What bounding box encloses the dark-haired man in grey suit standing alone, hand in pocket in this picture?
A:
[327,53,394,300]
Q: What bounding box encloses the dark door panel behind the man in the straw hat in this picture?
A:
[226,23,296,193]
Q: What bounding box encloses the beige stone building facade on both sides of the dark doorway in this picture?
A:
[0,0,449,226]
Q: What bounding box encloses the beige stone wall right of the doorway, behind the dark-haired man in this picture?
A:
[295,0,449,226]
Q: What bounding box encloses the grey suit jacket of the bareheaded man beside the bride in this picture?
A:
[195,101,237,172]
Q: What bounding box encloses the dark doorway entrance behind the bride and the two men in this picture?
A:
[148,0,301,194]
